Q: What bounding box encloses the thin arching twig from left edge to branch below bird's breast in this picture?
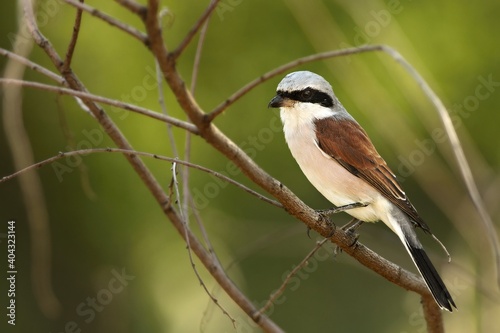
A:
[0,148,282,207]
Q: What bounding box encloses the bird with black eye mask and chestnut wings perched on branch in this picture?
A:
[268,71,456,312]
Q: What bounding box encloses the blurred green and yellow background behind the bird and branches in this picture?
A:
[0,0,500,333]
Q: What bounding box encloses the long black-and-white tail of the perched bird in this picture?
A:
[390,208,456,312]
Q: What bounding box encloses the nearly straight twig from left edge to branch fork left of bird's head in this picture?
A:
[0,78,198,134]
